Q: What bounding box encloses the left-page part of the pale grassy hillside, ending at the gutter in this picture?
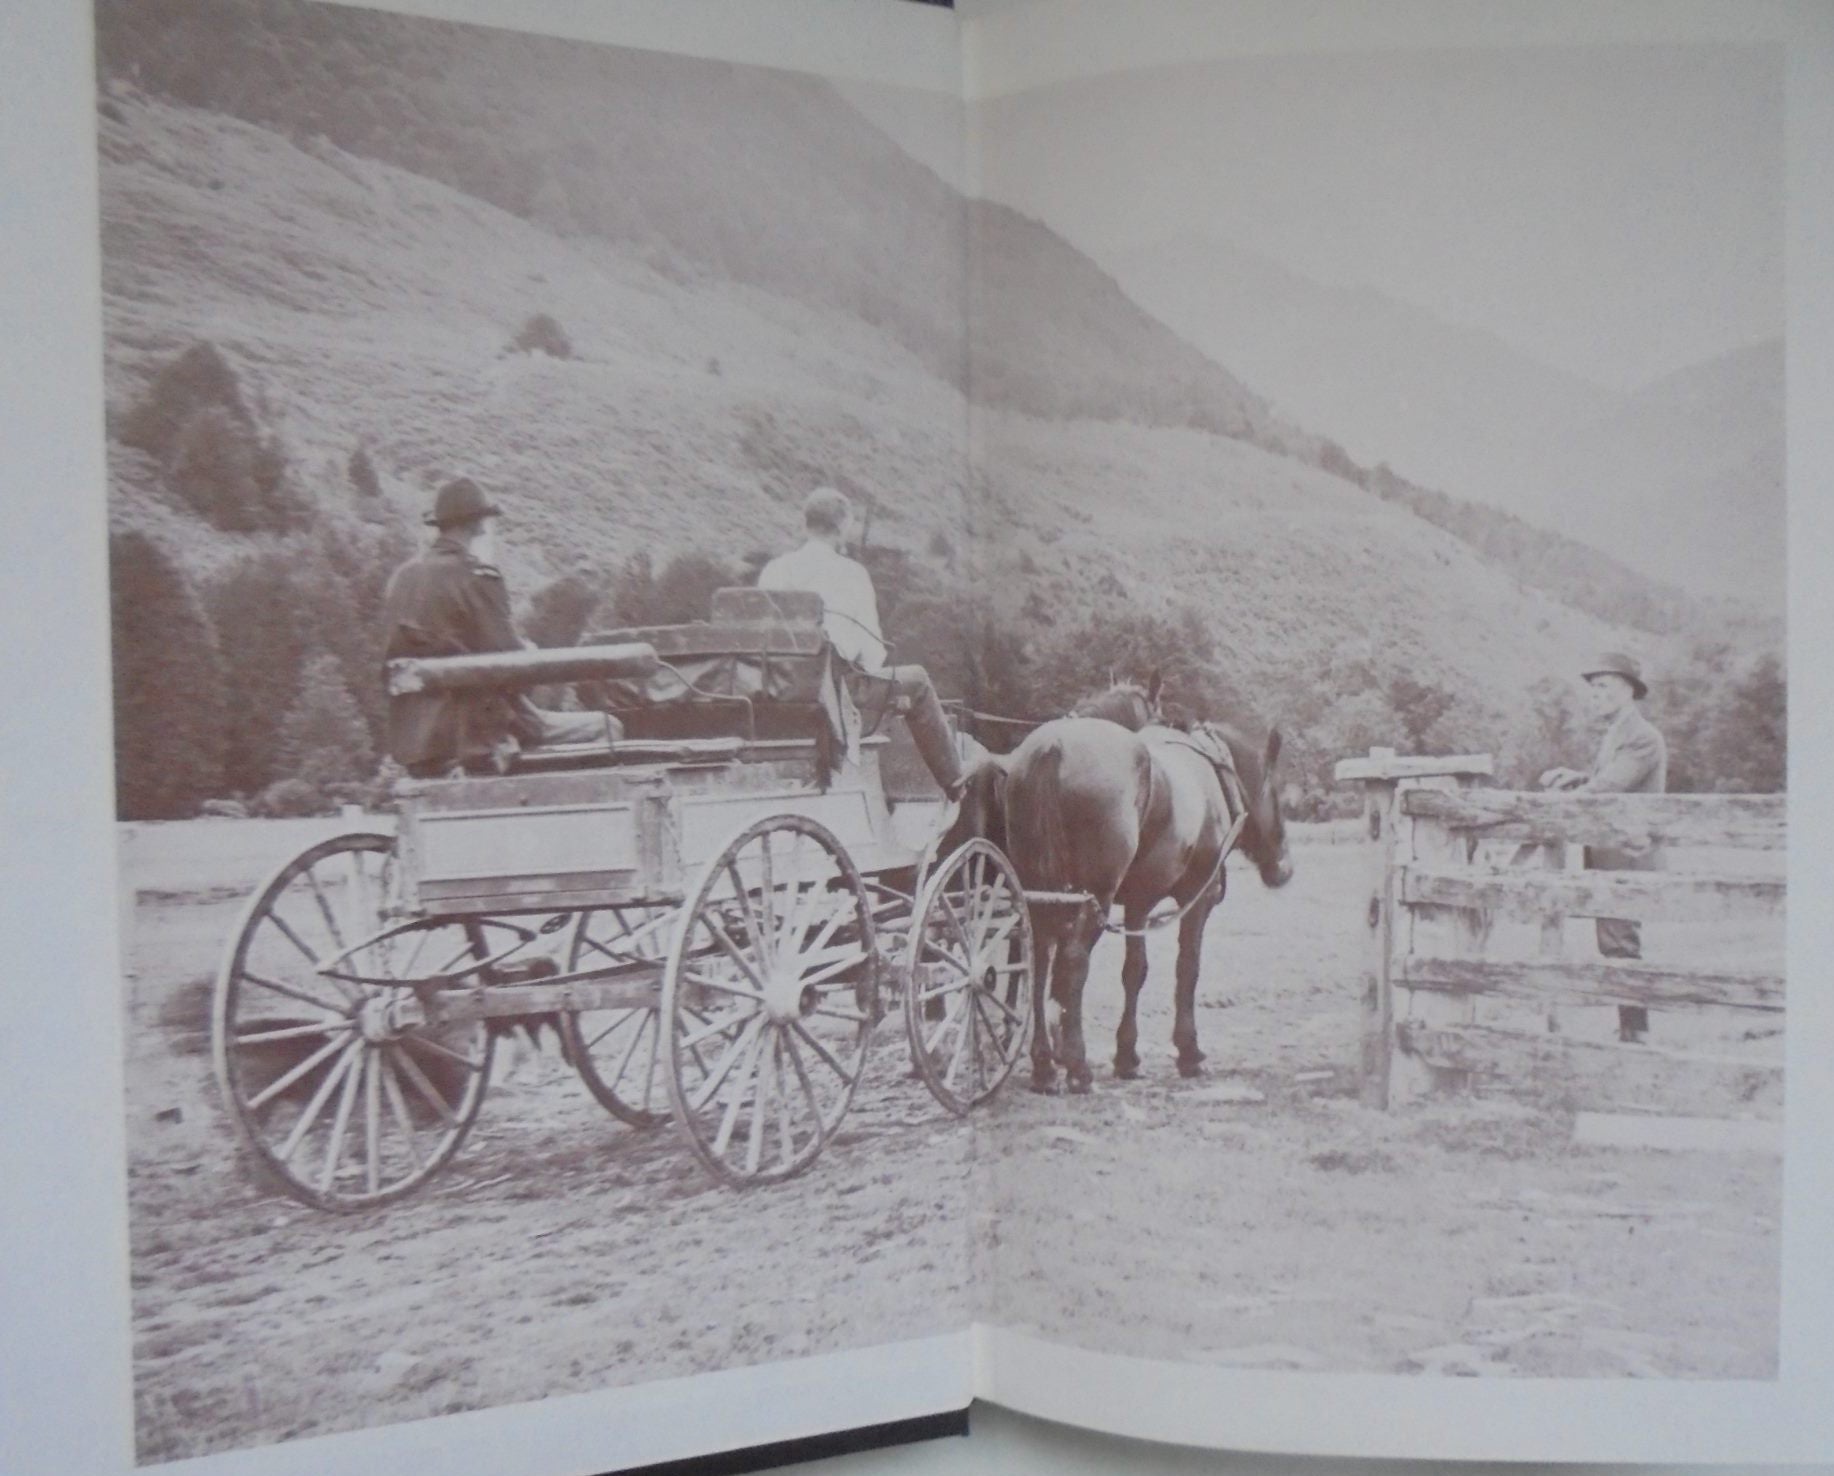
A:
[101,89,965,589]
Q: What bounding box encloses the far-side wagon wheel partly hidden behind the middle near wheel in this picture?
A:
[561,908,673,1128]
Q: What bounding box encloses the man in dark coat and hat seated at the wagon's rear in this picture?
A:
[381,477,616,776]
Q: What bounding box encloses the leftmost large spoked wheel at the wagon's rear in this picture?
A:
[211,834,501,1210]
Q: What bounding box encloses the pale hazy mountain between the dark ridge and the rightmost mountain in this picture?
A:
[1111,237,1619,506]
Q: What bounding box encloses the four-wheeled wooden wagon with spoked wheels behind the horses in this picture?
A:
[213,590,1034,1210]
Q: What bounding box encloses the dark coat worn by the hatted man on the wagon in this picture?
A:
[381,537,521,772]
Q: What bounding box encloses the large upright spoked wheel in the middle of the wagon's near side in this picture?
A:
[662,814,880,1184]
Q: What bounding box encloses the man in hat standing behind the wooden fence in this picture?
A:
[1541,651,1669,1041]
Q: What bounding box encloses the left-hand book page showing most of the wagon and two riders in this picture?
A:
[0,0,972,1476]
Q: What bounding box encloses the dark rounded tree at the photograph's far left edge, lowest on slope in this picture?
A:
[108,532,226,820]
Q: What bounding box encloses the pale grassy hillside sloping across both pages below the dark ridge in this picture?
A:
[99,74,1775,810]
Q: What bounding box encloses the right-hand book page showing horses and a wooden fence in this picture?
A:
[967,4,1834,1461]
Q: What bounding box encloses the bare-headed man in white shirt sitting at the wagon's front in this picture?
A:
[757,488,967,801]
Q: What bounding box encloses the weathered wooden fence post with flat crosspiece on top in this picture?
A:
[1335,748,1493,1107]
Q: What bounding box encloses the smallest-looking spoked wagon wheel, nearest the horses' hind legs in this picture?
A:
[904,840,1036,1115]
